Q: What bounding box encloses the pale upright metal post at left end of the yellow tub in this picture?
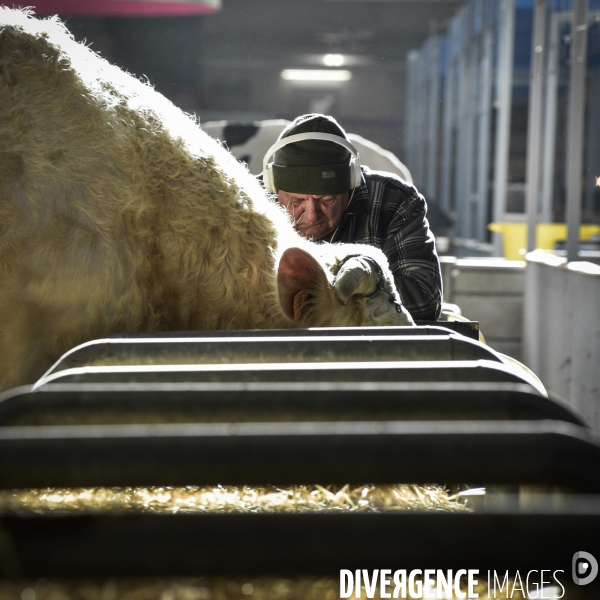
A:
[493,0,515,255]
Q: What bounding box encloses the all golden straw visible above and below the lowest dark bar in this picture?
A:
[0,485,564,600]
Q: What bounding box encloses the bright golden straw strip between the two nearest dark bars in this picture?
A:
[0,485,469,514]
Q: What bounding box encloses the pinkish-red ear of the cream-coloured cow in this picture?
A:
[277,248,327,321]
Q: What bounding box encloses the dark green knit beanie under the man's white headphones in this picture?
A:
[273,114,351,196]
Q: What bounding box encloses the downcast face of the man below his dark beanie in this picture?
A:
[277,190,348,240]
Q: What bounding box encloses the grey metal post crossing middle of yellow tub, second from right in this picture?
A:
[525,0,546,252]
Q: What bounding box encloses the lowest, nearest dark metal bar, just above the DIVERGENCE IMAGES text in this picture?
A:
[0,505,600,580]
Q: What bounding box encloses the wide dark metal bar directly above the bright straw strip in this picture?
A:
[0,421,600,492]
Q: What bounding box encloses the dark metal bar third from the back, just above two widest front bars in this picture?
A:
[0,383,585,426]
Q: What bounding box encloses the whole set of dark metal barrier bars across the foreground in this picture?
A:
[0,327,584,589]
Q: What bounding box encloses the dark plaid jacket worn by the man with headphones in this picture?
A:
[322,167,442,321]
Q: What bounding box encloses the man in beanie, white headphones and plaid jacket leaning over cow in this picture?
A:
[263,114,442,320]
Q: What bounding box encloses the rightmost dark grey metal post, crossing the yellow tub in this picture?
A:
[567,0,588,262]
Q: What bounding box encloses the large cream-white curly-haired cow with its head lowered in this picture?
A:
[0,7,412,389]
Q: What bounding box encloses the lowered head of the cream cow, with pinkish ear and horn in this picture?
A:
[277,248,414,327]
